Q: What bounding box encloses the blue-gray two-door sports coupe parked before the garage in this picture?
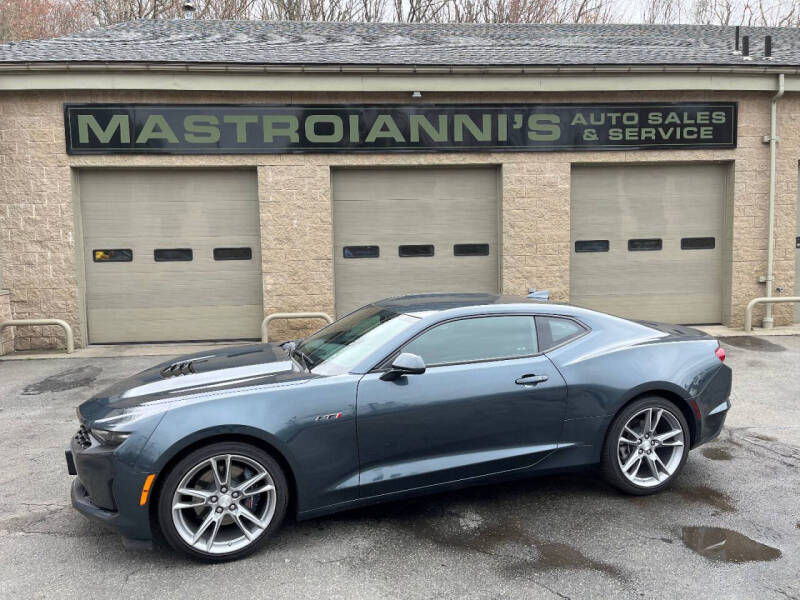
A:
[67,294,731,561]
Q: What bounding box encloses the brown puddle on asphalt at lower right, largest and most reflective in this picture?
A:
[681,527,781,563]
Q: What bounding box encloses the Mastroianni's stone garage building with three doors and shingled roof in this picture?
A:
[0,21,800,350]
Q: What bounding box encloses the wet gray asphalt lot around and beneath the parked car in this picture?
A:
[0,337,800,600]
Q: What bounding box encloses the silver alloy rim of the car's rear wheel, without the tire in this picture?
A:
[617,407,686,488]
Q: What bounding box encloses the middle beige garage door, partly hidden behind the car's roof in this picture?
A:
[333,168,498,315]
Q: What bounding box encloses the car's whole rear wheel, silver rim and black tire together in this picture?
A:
[601,396,689,496]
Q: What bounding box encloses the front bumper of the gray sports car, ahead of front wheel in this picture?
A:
[66,428,152,540]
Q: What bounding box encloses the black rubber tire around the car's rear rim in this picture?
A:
[600,396,690,496]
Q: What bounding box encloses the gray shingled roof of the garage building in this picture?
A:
[0,19,800,67]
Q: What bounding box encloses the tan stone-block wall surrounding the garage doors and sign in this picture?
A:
[0,86,800,349]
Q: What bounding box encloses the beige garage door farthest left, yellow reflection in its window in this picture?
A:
[80,169,263,343]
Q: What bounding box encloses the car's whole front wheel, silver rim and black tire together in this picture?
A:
[158,442,288,562]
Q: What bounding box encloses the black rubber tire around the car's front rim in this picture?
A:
[157,442,289,562]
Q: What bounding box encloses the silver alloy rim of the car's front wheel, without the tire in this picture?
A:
[171,454,277,554]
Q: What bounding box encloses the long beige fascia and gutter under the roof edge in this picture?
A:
[0,62,800,94]
